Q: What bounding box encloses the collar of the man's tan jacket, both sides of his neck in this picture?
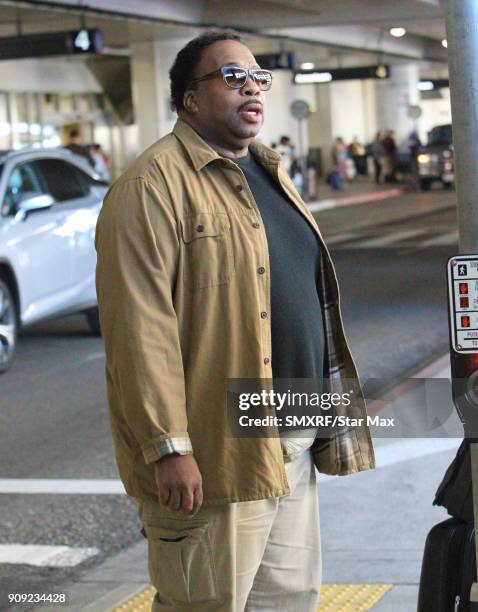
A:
[173,117,281,171]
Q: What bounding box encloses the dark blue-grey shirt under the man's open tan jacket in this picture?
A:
[234,152,324,381]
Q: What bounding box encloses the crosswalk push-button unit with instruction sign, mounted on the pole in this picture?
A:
[447,255,478,438]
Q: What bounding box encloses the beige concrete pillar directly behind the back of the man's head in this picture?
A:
[131,33,195,152]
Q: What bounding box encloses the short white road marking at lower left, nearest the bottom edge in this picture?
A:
[0,544,99,567]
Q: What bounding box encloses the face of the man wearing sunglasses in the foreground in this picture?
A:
[185,40,264,148]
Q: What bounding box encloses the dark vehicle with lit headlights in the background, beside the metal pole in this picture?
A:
[417,123,455,191]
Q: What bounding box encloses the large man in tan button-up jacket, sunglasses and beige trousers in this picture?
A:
[96,32,374,612]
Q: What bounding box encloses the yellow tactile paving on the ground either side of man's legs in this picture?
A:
[112,584,392,612]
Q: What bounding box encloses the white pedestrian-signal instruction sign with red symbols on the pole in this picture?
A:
[447,255,478,353]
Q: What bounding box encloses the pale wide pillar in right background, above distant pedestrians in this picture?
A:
[375,64,420,147]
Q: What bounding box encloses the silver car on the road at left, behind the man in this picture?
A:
[0,149,108,373]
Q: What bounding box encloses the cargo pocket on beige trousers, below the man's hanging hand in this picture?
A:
[145,524,217,603]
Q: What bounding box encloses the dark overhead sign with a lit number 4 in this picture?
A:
[0,28,103,60]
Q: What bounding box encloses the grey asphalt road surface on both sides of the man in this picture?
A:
[0,186,456,610]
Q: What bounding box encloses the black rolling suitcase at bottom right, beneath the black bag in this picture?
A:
[417,518,478,612]
